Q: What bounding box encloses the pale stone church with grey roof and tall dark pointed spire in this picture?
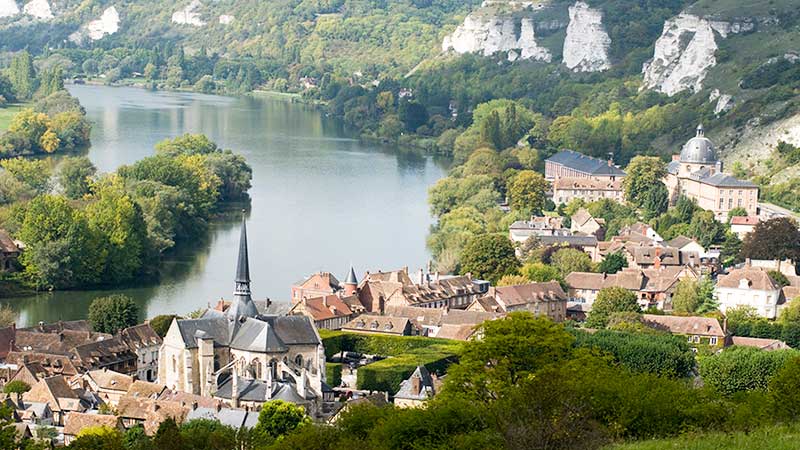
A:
[158,219,325,413]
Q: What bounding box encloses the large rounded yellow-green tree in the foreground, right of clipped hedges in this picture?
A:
[443,313,573,401]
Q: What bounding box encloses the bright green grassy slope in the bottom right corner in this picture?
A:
[606,425,800,450]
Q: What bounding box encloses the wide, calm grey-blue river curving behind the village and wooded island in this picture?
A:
[4,86,446,326]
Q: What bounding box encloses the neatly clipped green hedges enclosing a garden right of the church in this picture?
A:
[320,330,461,393]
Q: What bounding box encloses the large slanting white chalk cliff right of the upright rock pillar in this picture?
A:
[642,14,754,96]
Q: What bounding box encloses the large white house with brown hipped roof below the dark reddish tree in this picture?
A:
[714,264,781,319]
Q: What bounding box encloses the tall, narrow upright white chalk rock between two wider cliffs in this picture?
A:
[564,1,611,72]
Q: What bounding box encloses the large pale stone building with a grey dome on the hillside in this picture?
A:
[664,125,758,221]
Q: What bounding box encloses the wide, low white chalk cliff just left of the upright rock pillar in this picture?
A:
[442,13,552,62]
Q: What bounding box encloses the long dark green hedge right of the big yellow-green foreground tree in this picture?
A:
[572,330,694,378]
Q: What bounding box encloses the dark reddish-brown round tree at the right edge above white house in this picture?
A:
[742,217,800,261]
